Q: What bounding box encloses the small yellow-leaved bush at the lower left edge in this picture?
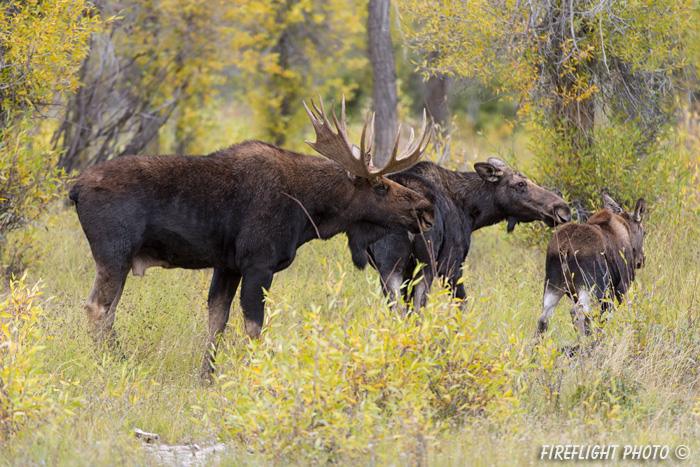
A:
[0,274,78,441]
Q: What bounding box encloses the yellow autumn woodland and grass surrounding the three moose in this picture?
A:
[0,0,700,465]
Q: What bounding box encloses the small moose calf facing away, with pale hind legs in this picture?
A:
[535,194,647,337]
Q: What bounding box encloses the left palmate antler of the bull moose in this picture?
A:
[304,96,375,178]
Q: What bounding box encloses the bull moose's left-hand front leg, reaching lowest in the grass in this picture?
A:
[199,269,241,379]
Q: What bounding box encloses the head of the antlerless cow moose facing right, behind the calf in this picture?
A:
[474,157,571,232]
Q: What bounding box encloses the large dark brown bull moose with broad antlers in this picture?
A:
[69,97,434,379]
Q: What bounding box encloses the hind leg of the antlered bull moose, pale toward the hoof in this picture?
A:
[85,263,129,348]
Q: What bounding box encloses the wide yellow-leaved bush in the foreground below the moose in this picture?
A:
[193,276,527,461]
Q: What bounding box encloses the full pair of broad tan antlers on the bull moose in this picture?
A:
[304,95,432,179]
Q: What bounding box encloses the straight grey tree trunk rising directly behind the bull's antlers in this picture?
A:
[367,0,399,167]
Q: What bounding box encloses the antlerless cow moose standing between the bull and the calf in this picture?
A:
[364,157,571,308]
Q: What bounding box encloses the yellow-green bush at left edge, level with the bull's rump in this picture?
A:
[0,117,61,278]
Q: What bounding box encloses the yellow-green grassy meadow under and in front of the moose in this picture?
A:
[0,191,700,466]
